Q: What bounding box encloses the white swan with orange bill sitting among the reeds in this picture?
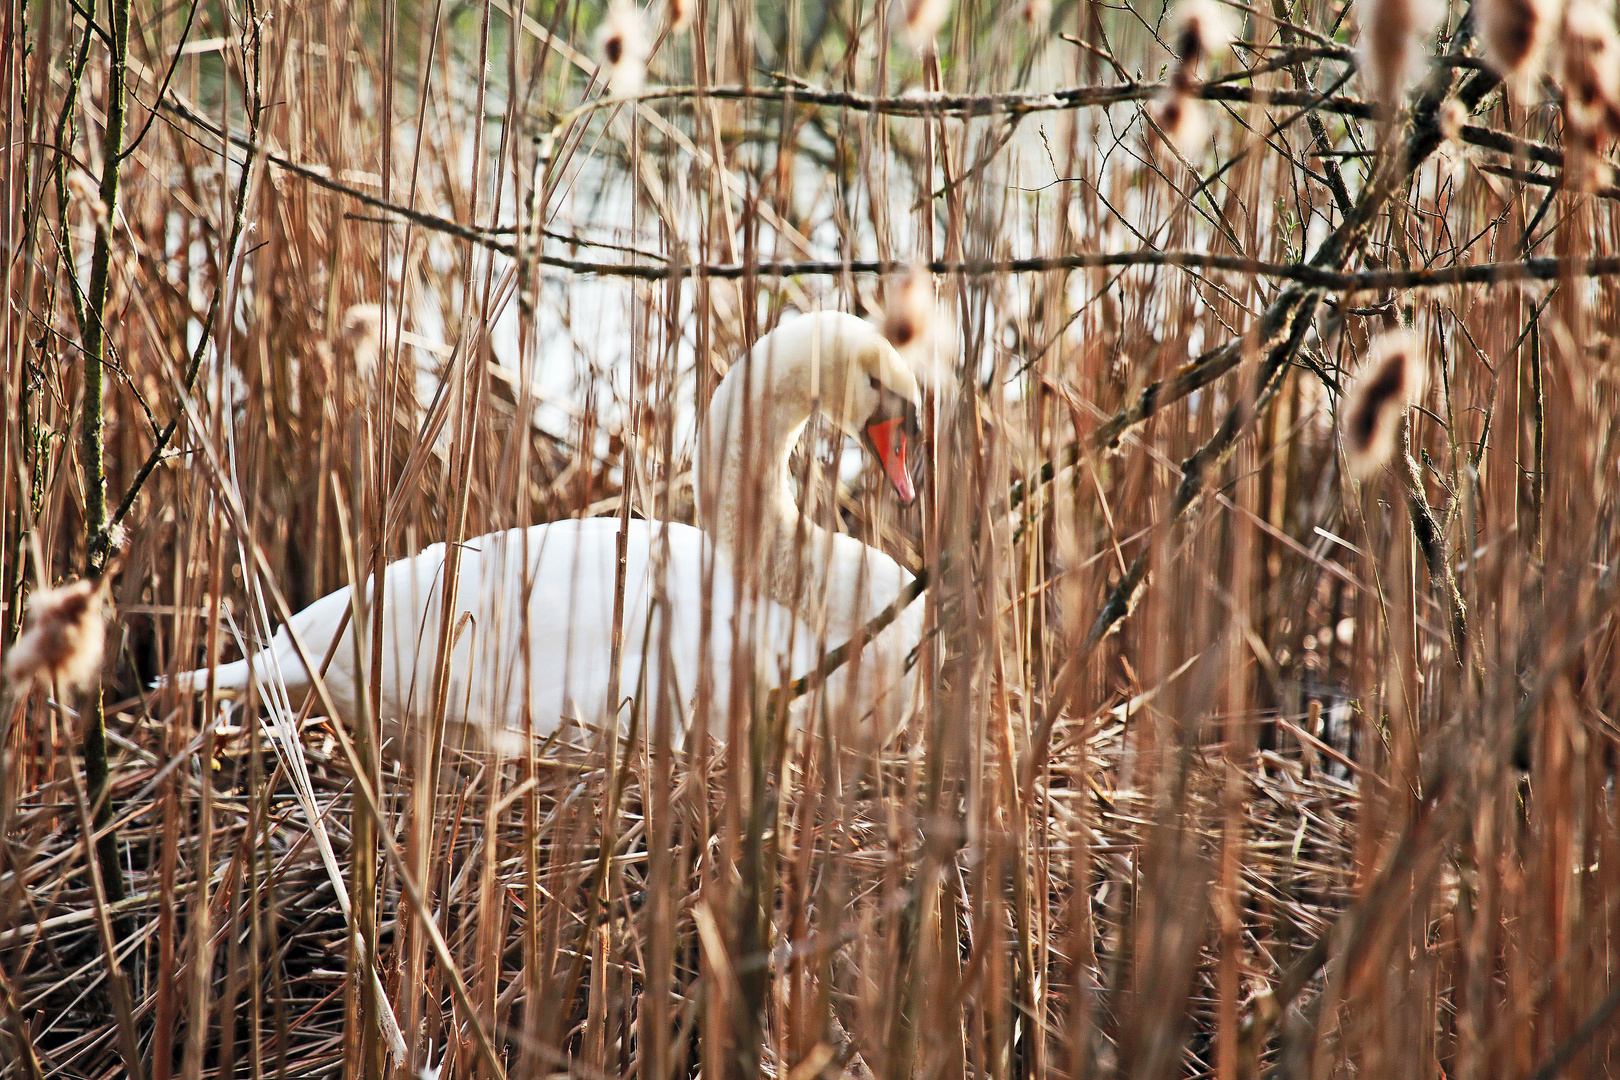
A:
[172,313,922,750]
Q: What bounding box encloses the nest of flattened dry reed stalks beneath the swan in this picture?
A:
[0,680,1380,1075]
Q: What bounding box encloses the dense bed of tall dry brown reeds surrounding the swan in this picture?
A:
[0,0,1620,1080]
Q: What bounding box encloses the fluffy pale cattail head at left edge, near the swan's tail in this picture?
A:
[5,557,118,691]
